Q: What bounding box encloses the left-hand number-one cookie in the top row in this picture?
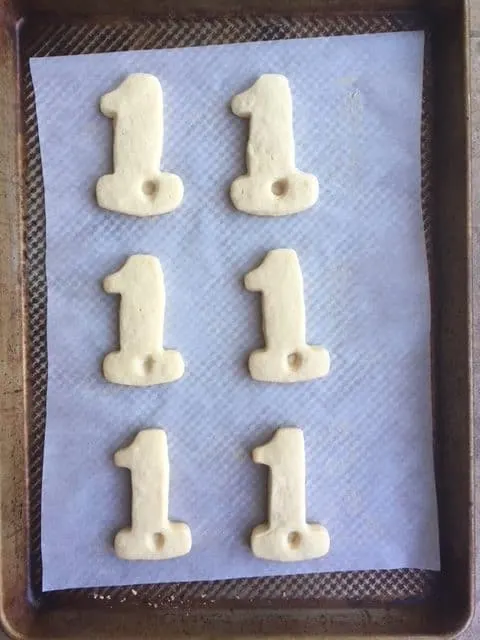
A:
[97,73,183,216]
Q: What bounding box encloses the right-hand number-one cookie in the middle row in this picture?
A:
[245,249,330,382]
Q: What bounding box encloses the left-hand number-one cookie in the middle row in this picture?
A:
[103,255,185,387]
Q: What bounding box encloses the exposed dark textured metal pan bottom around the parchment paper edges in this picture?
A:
[22,14,439,608]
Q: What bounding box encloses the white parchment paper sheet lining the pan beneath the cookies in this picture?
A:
[31,32,439,590]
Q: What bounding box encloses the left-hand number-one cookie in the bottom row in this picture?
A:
[114,429,192,560]
